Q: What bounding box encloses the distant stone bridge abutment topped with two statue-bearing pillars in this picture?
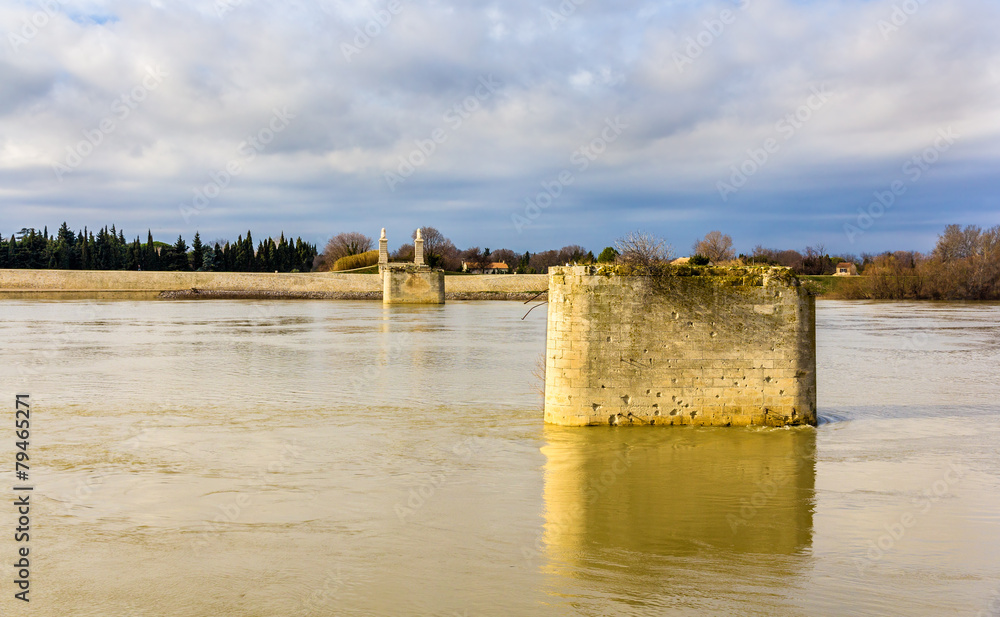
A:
[378,227,444,304]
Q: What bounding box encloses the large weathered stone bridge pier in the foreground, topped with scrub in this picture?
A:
[545,265,816,426]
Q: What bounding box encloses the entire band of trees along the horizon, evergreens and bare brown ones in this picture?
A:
[0,222,1000,300]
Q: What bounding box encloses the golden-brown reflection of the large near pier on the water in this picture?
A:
[542,427,816,614]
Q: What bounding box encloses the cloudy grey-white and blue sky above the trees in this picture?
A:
[0,0,1000,253]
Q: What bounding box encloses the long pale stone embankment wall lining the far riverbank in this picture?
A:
[0,269,548,301]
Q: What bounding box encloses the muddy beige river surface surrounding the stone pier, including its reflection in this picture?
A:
[0,300,1000,617]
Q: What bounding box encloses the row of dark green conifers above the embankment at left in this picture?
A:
[0,222,317,272]
